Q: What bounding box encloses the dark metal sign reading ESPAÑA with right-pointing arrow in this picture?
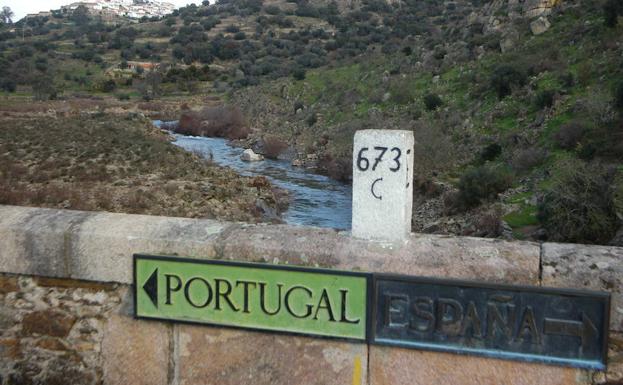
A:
[372,274,610,370]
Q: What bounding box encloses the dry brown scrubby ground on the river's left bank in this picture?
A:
[0,113,277,222]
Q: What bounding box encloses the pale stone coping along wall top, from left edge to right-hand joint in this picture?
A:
[0,206,540,285]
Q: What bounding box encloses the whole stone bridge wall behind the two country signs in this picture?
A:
[0,206,623,385]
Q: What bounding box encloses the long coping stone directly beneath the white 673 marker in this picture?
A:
[217,226,540,284]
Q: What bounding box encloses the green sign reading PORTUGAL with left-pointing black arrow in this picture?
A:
[134,255,371,340]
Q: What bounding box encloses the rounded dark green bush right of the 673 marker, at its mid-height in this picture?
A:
[459,165,513,207]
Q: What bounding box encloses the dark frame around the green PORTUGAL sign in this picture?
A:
[132,253,374,344]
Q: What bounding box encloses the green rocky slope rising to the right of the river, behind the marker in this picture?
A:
[231,1,623,244]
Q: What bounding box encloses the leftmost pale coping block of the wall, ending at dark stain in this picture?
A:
[0,206,92,277]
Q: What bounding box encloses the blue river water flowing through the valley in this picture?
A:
[154,121,352,230]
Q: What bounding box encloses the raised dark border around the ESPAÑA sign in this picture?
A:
[370,273,611,370]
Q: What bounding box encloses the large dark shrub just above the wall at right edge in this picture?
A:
[538,160,618,243]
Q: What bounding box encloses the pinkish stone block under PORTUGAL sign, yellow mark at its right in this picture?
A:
[176,325,367,385]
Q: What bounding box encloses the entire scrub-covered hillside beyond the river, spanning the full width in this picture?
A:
[0,0,623,244]
